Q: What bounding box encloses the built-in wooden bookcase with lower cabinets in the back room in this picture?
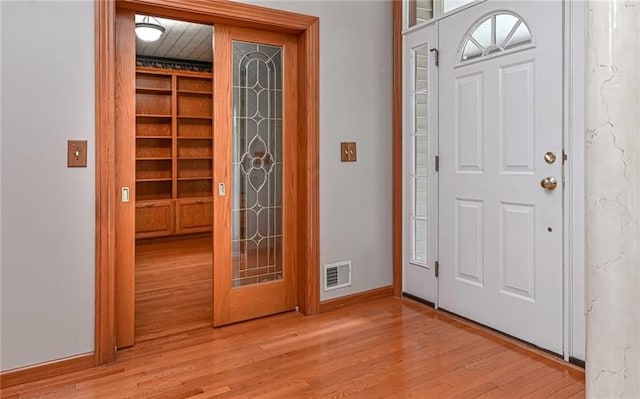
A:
[135,68,213,238]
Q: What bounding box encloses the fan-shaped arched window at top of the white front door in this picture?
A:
[460,11,533,62]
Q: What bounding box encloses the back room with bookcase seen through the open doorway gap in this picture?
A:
[135,15,214,341]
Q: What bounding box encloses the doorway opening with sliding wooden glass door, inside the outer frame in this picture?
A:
[115,5,316,348]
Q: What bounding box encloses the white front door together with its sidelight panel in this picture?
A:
[404,3,565,354]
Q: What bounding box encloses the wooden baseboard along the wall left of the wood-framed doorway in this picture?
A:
[0,353,94,389]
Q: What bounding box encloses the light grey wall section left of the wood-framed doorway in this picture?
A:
[0,1,95,371]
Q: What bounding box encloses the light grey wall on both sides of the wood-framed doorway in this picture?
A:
[0,1,392,371]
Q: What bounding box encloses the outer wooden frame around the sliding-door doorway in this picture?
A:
[94,0,320,364]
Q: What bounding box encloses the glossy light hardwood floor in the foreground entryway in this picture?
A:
[0,298,584,399]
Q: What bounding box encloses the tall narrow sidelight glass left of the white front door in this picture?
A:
[410,45,429,265]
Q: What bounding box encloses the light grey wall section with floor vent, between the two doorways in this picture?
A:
[246,0,393,300]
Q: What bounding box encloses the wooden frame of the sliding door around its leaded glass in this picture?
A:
[213,25,298,326]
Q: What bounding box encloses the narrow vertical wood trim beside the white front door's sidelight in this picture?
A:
[392,0,403,297]
